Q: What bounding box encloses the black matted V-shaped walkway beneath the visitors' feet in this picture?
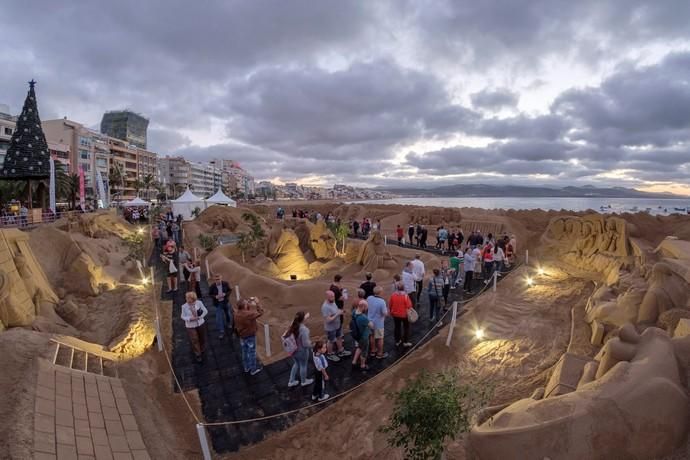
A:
[158,241,510,453]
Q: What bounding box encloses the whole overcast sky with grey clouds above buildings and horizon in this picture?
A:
[0,0,690,194]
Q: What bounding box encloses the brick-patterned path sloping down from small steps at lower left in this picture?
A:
[34,361,150,460]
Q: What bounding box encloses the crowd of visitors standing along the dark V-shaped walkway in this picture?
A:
[171,211,517,401]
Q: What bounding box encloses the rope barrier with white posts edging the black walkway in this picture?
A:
[150,244,529,460]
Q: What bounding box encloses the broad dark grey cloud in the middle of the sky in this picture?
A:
[218,60,475,159]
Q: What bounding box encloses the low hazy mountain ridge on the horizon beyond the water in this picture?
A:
[378,184,688,198]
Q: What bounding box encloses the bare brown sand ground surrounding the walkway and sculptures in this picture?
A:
[0,202,690,459]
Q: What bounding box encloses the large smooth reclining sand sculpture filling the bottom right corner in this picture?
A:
[470,325,688,459]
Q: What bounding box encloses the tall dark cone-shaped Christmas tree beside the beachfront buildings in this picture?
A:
[0,80,50,181]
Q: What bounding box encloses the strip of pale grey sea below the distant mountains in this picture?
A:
[350,196,690,215]
